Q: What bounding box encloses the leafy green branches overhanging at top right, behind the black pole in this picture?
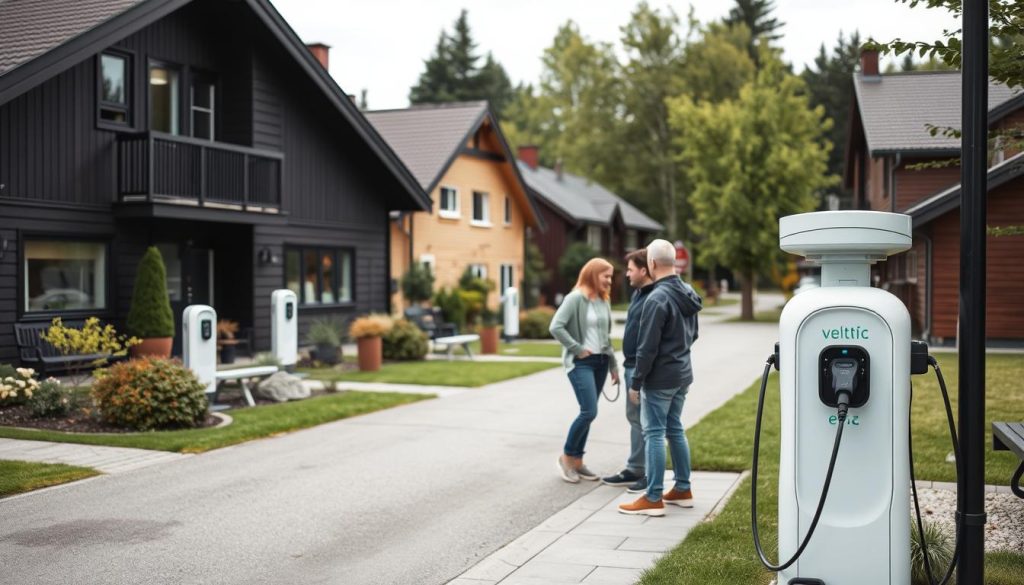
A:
[865,0,1024,87]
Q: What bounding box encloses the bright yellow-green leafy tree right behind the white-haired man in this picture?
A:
[670,61,835,320]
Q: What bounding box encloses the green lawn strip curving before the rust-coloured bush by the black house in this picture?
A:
[0,391,425,453]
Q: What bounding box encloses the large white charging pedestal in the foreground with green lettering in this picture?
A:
[778,211,911,585]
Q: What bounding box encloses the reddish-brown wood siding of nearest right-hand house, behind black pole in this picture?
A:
[930,178,1024,340]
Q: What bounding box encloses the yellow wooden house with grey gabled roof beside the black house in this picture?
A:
[367,101,542,308]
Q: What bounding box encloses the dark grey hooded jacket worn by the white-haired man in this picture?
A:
[633,276,703,390]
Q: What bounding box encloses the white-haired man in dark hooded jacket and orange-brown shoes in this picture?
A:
[618,240,702,516]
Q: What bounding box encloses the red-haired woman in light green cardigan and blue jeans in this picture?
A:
[551,258,618,484]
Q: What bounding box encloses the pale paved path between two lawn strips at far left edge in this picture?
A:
[0,438,193,474]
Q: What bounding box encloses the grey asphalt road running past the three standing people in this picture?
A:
[0,295,776,585]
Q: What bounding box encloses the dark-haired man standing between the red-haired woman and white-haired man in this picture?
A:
[601,248,654,493]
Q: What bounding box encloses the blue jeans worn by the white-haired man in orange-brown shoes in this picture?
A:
[640,386,690,502]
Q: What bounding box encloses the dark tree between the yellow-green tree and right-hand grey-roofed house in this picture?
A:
[800,31,860,207]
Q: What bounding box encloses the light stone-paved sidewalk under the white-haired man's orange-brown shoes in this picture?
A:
[449,471,740,585]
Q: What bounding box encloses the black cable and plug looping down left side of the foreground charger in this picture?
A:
[751,353,857,573]
